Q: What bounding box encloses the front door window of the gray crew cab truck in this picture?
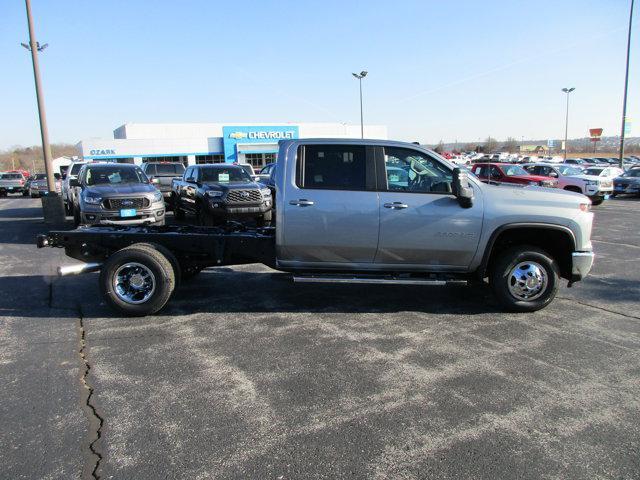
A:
[384,147,452,193]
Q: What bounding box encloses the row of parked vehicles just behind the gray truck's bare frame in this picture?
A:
[56,162,273,226]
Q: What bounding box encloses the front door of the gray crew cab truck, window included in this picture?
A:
[375,147,483,271]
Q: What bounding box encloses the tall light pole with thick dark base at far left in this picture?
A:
[22,0,65,223]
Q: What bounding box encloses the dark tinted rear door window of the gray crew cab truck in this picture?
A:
[296,145,367,190]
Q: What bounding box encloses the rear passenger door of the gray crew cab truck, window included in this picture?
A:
[277,142,379,269]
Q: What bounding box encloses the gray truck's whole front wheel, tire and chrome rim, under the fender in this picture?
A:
[489,246,560,312]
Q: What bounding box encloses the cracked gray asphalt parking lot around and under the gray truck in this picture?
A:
[0,197,640,479]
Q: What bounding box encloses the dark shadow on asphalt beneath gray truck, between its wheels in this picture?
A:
[166,269,500,315]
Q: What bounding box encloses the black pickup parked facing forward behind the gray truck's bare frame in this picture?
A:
[171,164,273,226]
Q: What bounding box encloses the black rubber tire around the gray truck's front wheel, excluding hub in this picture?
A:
[489,245,560,312]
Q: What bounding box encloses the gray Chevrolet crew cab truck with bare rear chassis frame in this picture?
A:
[38,139,594,315]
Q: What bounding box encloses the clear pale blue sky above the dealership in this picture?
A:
[0,0,640,149]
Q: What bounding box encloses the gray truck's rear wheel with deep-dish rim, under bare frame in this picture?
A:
[100,244,176,316]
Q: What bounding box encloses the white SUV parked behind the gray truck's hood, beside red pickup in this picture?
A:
[523,163,613,205]
